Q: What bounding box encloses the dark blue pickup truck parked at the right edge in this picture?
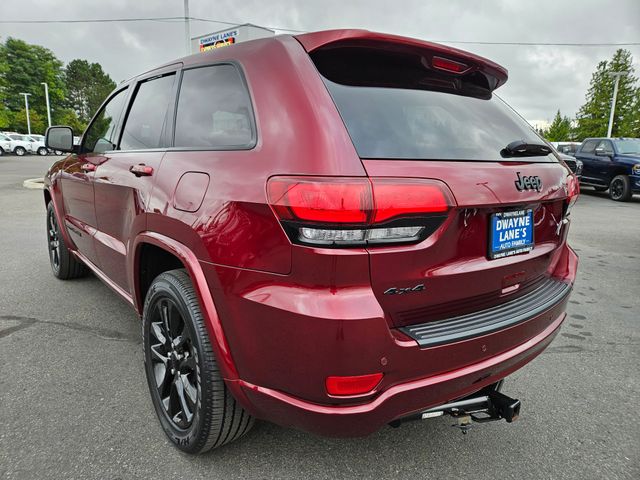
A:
[575,138,640,202]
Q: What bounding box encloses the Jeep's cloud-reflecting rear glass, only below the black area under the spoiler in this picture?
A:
[325,79,554,162]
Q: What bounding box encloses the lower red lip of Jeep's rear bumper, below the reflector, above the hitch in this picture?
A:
[232,313,566,437]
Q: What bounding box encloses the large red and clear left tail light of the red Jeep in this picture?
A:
[267,177,454,247]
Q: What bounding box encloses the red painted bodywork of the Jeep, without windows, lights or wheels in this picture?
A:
[45,30,577,436]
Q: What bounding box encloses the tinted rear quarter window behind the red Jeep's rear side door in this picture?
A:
[174,65,255,148]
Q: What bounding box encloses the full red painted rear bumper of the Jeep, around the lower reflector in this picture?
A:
[204,242,578,436]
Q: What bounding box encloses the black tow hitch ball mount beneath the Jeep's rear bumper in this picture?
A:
[389,380,520,434]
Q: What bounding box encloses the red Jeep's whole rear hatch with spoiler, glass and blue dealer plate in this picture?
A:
[298,31,571,326]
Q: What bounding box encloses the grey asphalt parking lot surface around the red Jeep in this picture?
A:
[0,156,640,479]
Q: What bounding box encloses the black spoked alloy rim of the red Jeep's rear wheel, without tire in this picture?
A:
[149,297,200,430]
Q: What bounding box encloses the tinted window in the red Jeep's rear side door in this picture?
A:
[120,73,176,150]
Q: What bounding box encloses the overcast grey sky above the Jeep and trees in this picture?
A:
[0,0,640,122]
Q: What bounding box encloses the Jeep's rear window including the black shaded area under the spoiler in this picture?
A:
[310,42,557,162]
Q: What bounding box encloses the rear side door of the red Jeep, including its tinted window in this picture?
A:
[94,65,179,293]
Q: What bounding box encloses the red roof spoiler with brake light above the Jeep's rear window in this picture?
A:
[295,30,508,91]
